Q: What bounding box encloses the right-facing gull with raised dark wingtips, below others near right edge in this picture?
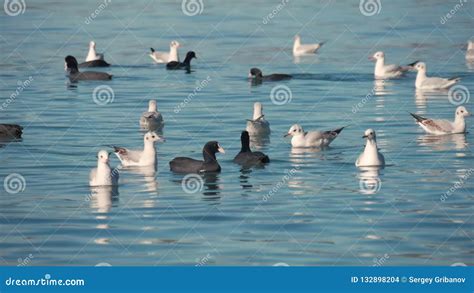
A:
[410,106,471,135]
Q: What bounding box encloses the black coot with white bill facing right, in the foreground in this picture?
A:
[170,141,225,173]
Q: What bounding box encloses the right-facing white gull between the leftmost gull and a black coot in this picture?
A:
[112,131,165,167]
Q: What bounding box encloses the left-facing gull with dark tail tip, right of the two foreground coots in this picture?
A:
[284,124,344,148]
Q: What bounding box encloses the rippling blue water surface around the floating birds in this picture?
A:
[0,0,474,266]
